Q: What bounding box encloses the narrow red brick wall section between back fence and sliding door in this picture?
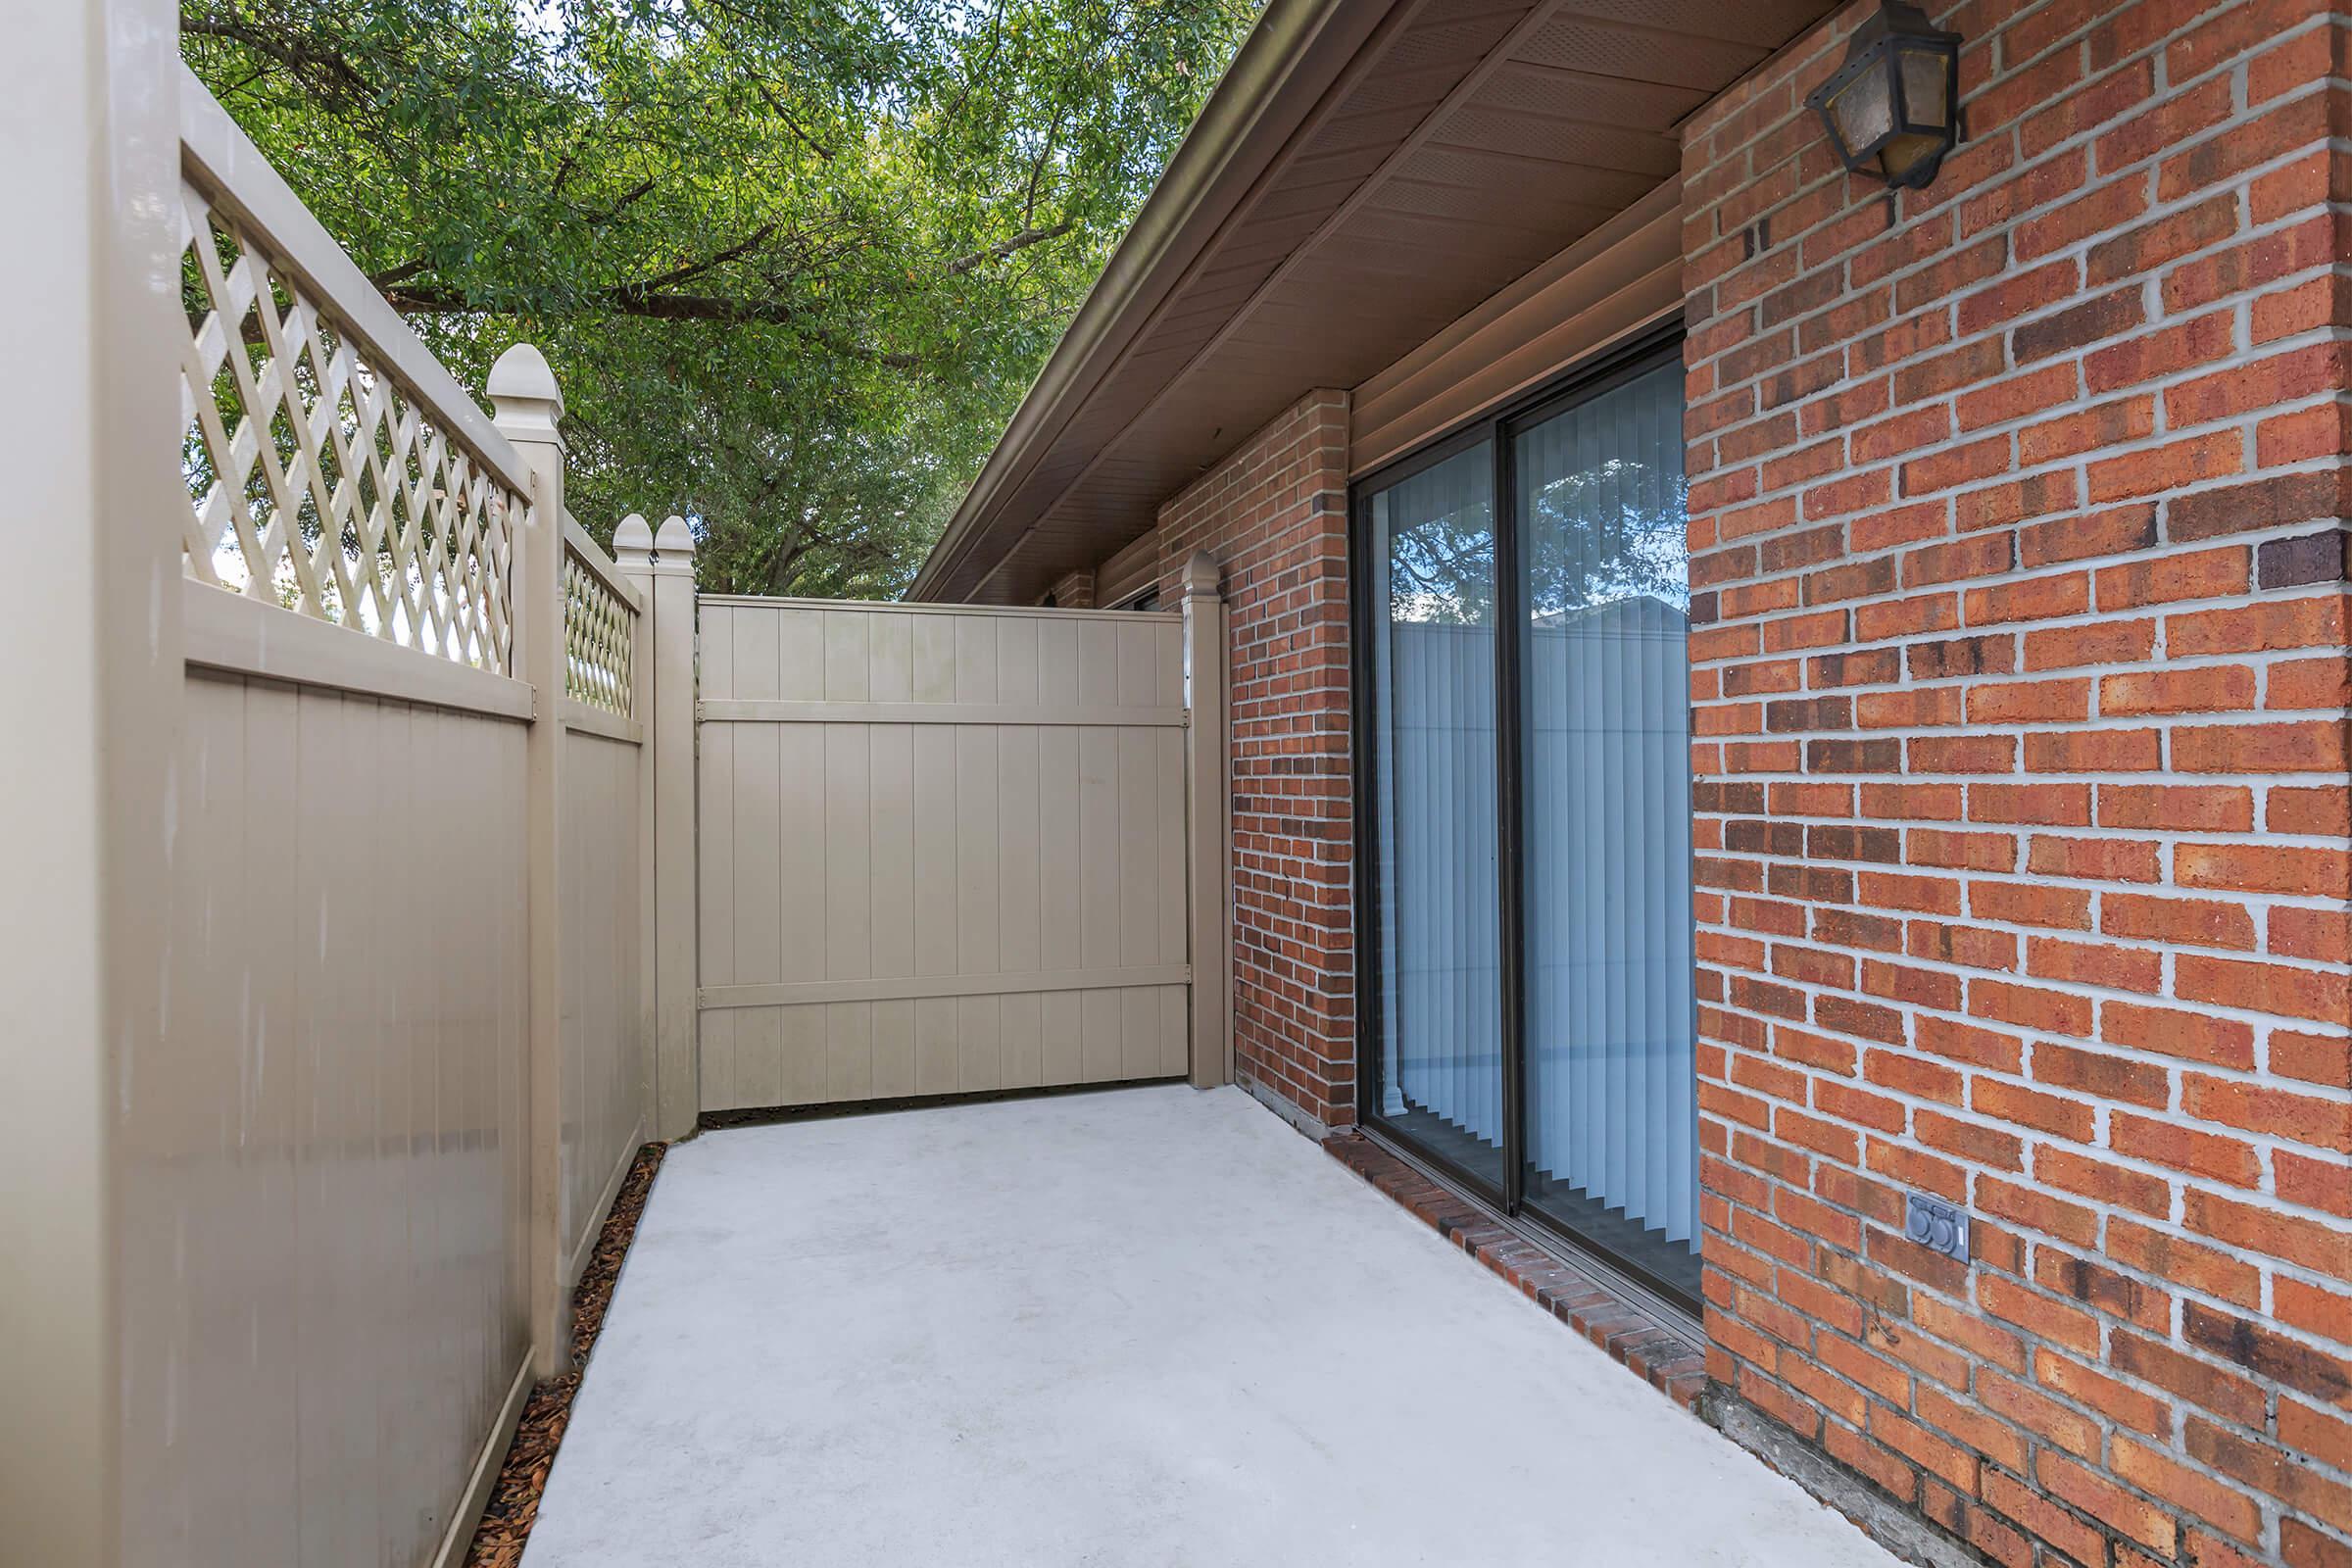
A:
[1159,393,1354,1126]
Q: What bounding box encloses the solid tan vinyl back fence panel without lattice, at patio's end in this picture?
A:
[699,597,1221,1109]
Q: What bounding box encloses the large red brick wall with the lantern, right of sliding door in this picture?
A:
[1684,0,2352,1568]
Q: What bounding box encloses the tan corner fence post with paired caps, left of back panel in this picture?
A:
[612,514,701,1138]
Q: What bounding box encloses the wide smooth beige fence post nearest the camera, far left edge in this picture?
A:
[0,0,180,1568]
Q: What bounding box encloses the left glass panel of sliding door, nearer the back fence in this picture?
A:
[1366,442,1503,1187]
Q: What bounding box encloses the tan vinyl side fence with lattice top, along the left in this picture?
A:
[16,66,692,1566]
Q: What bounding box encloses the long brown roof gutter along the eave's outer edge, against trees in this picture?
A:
[906,0,1390,600]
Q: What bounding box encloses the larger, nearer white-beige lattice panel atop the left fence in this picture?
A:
[178,181,529,674]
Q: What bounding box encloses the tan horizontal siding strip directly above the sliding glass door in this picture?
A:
[1348,181,1682,477]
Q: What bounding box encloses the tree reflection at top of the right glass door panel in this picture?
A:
[1527,459,1691,620]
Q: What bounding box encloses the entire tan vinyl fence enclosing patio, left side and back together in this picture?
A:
[14,27,1230,1568]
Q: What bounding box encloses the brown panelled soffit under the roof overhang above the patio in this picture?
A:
[915,0,1833,602]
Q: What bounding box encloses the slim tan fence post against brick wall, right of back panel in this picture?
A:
[1183,550,1233,1089]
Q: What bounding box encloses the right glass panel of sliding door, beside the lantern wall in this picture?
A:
[1512,360,1698,1298]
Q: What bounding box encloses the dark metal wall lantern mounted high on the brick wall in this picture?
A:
[1804,0,1959,190]
